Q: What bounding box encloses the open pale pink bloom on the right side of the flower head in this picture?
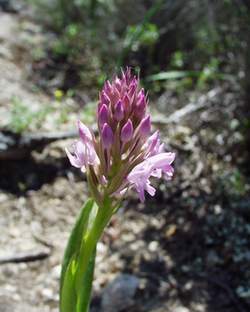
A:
[127,153,175,201]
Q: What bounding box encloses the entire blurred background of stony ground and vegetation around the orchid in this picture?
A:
[0,0,250,312]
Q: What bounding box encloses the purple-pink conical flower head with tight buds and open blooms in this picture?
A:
[66,68,175,203]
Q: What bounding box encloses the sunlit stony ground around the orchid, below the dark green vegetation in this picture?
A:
[0,2,250,312]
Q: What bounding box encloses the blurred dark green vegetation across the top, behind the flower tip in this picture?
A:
[26,0,250,89]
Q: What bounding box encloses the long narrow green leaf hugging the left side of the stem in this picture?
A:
[60,199,95,312]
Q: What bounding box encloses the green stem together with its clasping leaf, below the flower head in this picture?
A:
[60,197,116,312]
